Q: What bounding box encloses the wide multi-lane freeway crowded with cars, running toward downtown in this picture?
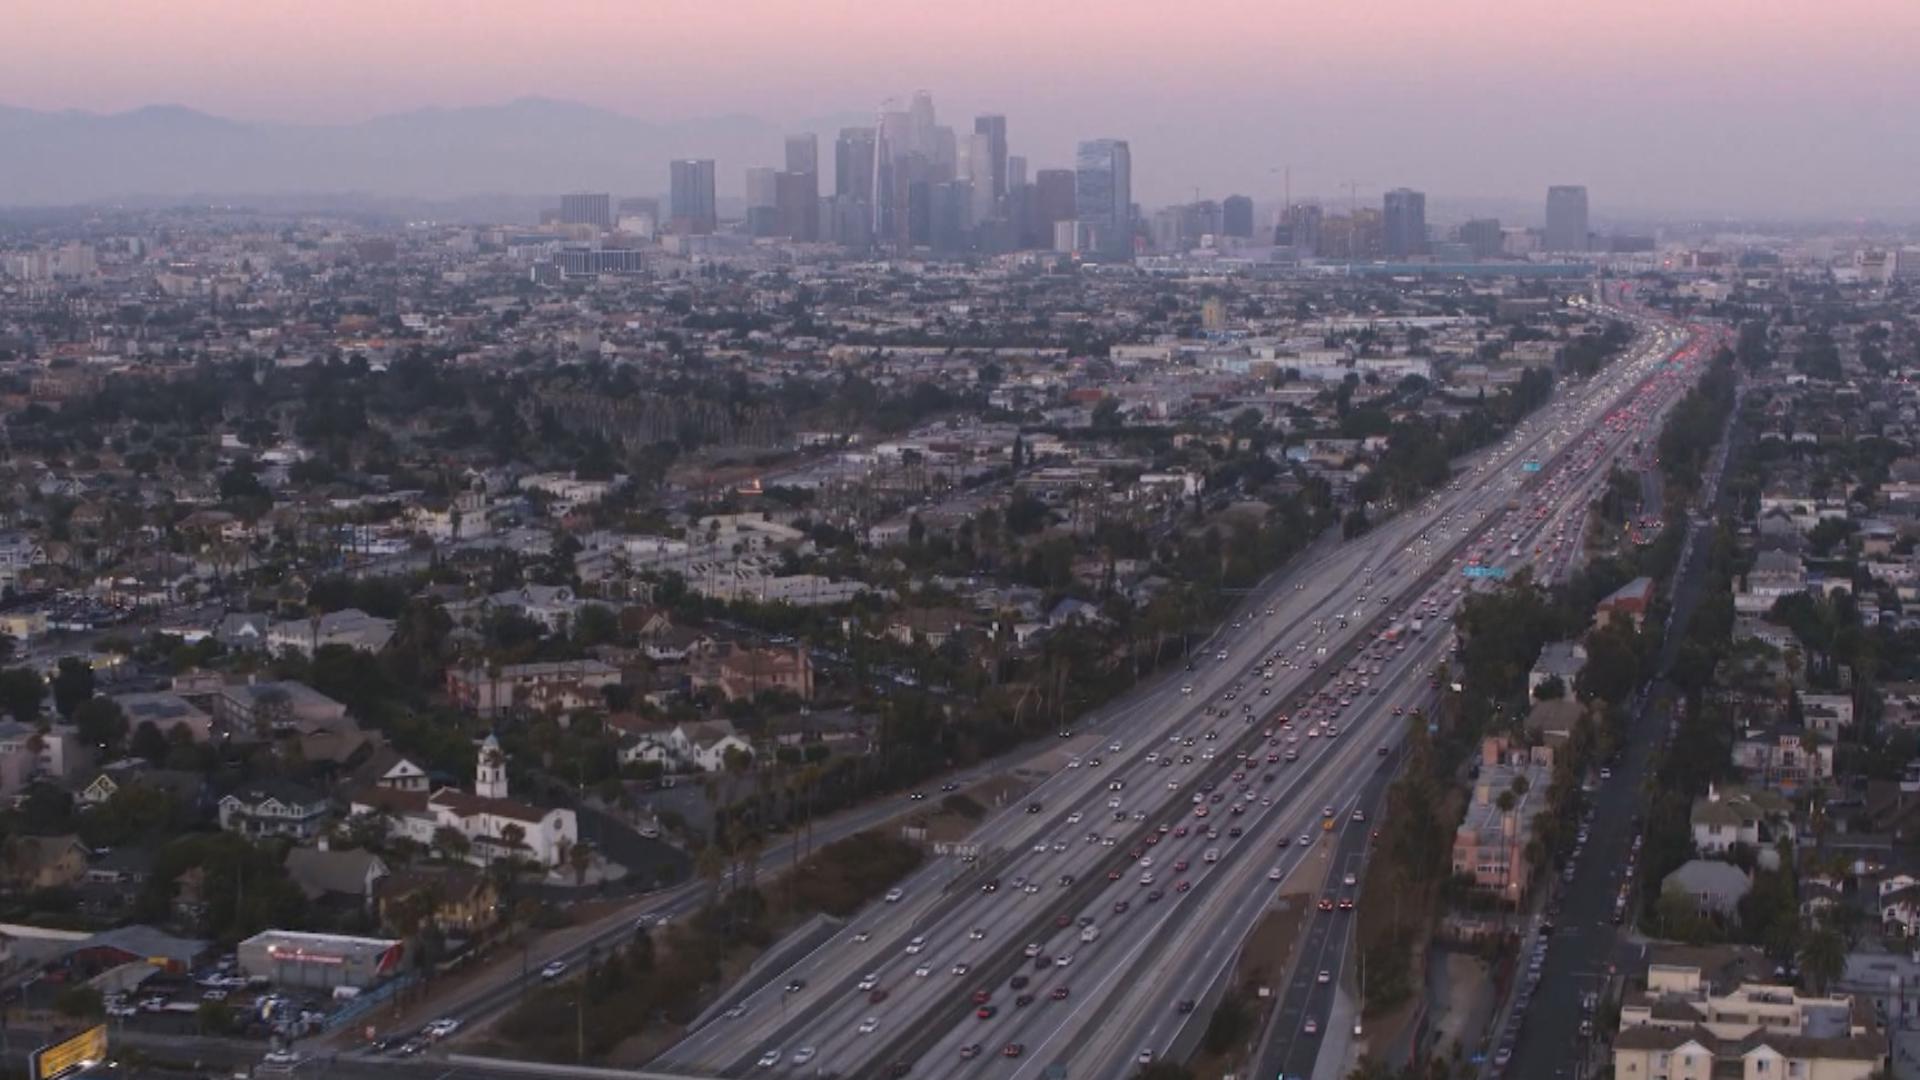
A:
[657,311,1712,1078]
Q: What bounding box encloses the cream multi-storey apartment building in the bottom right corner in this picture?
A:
[1613,949,1887,1080]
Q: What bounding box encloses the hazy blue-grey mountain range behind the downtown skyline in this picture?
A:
[0,98,872,206]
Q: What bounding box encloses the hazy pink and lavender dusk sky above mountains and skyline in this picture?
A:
[0,0,1920,215]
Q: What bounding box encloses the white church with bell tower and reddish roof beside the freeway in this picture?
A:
[351,734,580,867]
